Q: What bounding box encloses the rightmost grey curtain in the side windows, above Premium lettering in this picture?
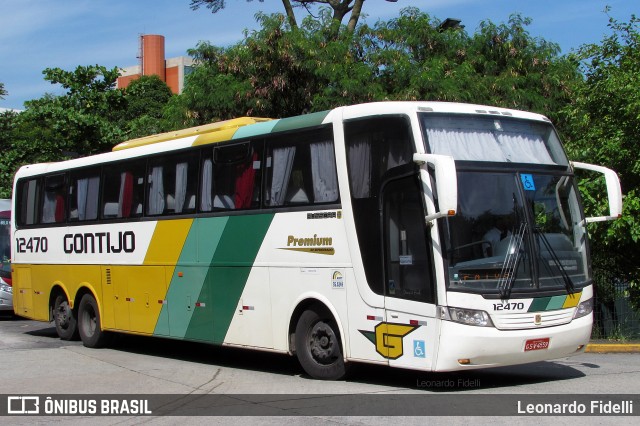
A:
[311,141,338,203]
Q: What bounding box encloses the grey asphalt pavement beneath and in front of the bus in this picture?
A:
[0,315,640,425]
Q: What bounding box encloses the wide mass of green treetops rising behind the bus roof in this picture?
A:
[170,8,579,126]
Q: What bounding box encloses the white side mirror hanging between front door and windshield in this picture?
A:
[413,154,458,223]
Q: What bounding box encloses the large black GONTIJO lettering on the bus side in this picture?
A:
[63,231,136,254]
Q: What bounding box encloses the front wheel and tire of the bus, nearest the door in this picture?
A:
[295,310,346,380]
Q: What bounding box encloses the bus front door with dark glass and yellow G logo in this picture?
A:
[381,173,437,370]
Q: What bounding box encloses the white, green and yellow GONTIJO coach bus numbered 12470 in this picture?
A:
[12,102,622,379]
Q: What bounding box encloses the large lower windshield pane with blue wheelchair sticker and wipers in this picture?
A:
[444,171,588,296]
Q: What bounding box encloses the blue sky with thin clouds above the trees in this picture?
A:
[0,0,640,110]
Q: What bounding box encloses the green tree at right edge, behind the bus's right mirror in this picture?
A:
[565,16,640,308]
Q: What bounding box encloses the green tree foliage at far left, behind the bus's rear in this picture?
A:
[0,65,172,197]
